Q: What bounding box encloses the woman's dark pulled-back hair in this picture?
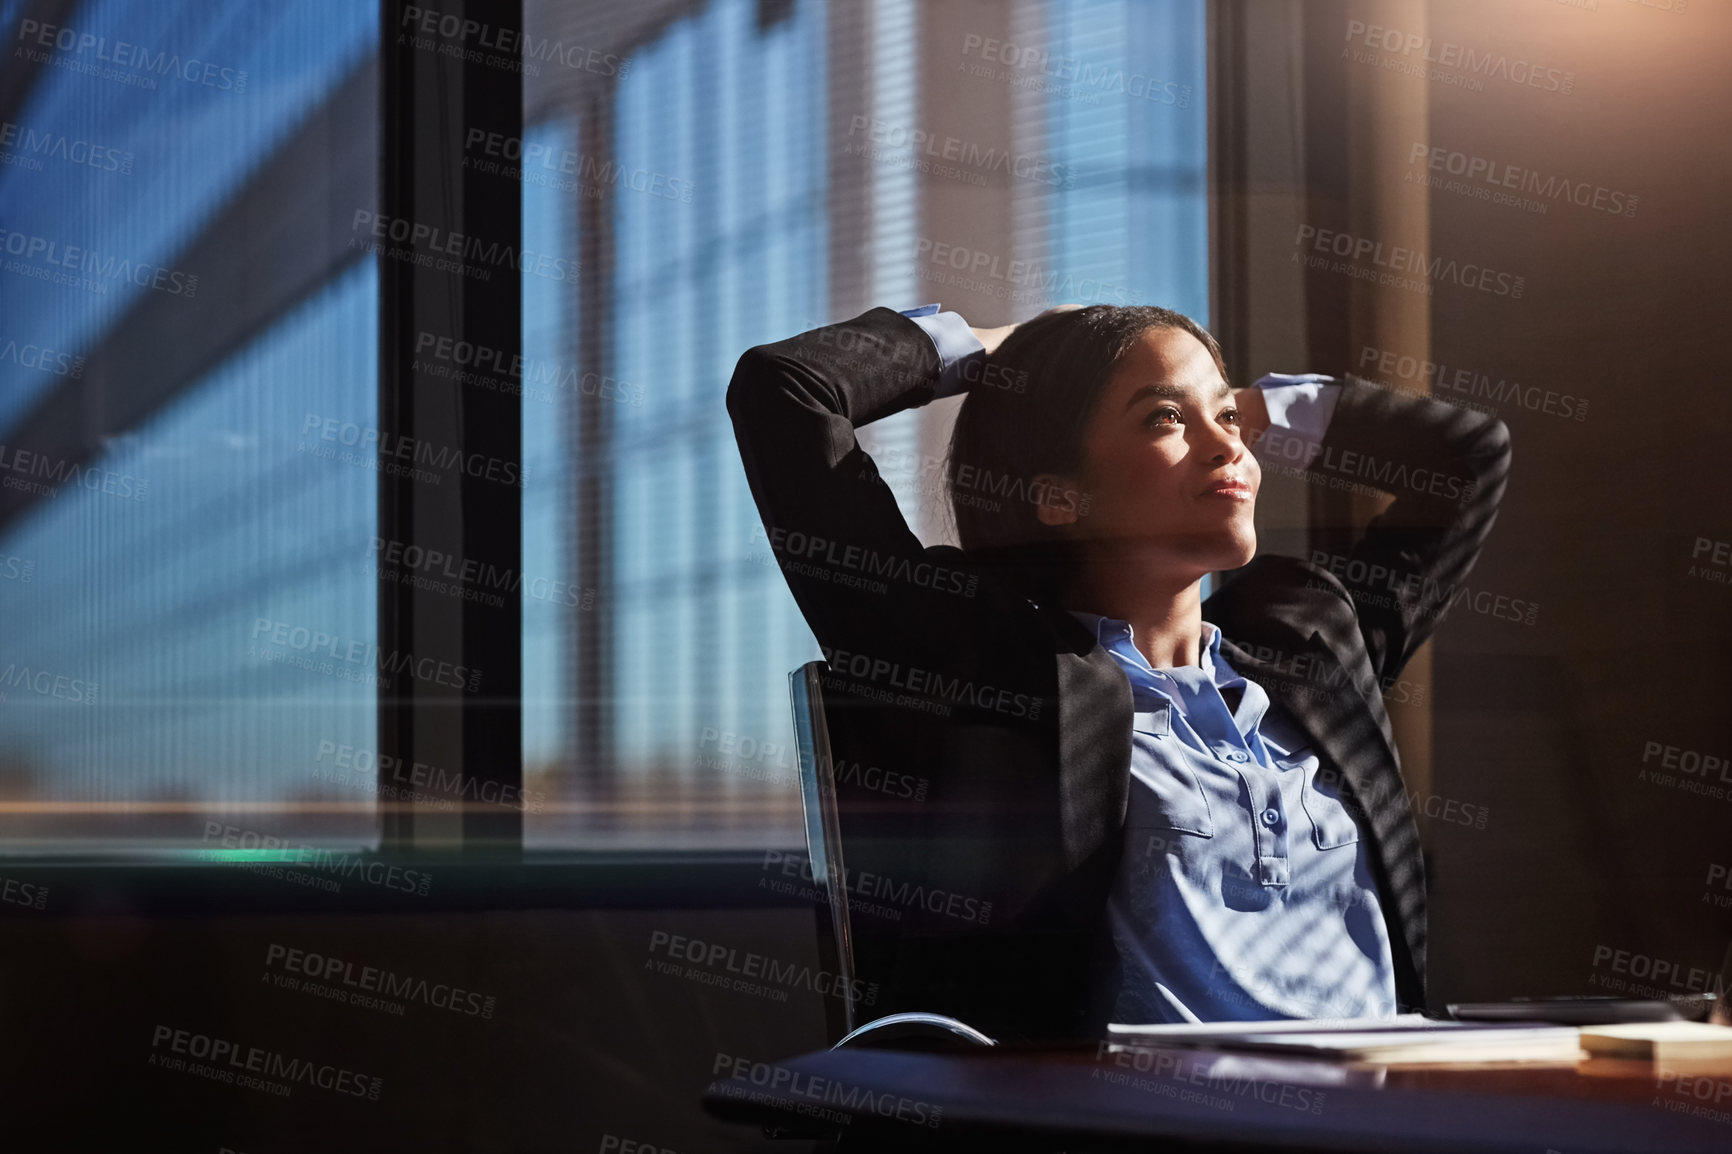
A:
[947,305,1226,598]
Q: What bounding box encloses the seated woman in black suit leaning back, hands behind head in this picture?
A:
[727,305,1509,1038]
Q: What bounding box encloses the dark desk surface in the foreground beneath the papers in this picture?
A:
[703,1043,1732,1154]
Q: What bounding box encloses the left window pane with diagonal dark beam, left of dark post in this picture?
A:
[0,0,378,853]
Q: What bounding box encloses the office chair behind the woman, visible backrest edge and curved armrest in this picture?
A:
[788,662,998,1050]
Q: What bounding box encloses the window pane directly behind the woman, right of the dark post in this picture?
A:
[523,0,1207,847]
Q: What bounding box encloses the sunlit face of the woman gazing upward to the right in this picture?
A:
[1043,327,1263,584]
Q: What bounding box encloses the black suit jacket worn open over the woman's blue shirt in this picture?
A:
[727,308,1509,1038]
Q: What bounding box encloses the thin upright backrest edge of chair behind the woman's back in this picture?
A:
[788,662,856,1043]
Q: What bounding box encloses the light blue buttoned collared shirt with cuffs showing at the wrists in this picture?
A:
[902,305,1396,1022]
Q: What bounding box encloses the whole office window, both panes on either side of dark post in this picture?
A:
[0,0,1207,853]
